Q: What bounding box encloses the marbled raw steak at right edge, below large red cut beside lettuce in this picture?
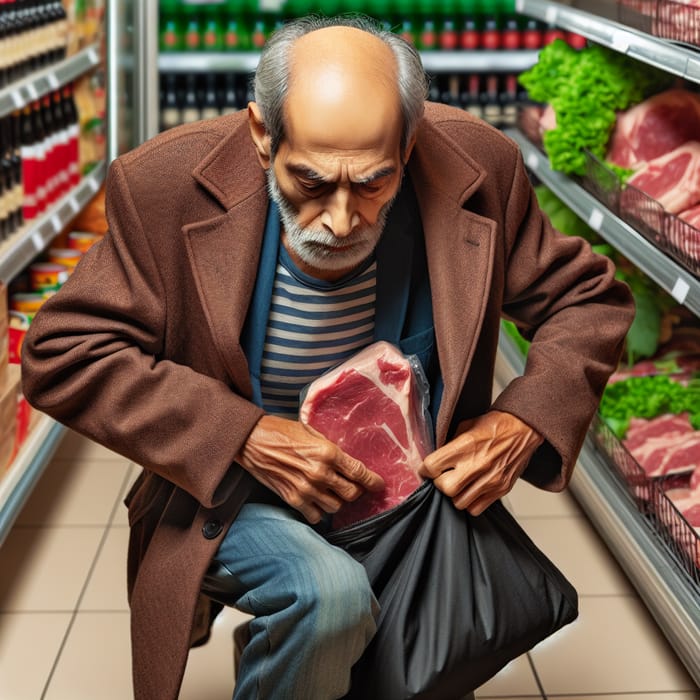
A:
[623,141,700,214]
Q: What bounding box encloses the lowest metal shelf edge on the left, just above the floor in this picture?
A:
[0,416,66,546]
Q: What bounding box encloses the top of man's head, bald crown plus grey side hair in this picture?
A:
[254,17,428,155]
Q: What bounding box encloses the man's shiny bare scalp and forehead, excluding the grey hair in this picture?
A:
[285,26,403,150]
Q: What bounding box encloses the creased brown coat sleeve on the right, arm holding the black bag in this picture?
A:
[494,149,634,489]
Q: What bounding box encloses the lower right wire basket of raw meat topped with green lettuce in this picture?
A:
[592,350,700,585]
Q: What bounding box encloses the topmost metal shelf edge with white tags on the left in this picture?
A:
[0,44,100,117]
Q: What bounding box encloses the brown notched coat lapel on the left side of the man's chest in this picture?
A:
[183,120,268,397]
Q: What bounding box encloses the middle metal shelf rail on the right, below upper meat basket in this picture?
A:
[506,129,700,316]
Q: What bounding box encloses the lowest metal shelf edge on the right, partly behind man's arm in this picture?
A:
[496,333,700,686]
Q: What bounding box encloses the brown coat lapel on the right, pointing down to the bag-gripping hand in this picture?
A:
[410,112,495,444]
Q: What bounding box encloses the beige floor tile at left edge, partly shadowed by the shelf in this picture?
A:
[0,527,104,612]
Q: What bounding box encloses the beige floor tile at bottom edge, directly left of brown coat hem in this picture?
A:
[43,612,133,700]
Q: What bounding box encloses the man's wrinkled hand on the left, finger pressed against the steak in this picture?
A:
[236,416,384,523]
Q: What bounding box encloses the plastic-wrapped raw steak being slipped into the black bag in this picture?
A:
[300,342,431,528]
